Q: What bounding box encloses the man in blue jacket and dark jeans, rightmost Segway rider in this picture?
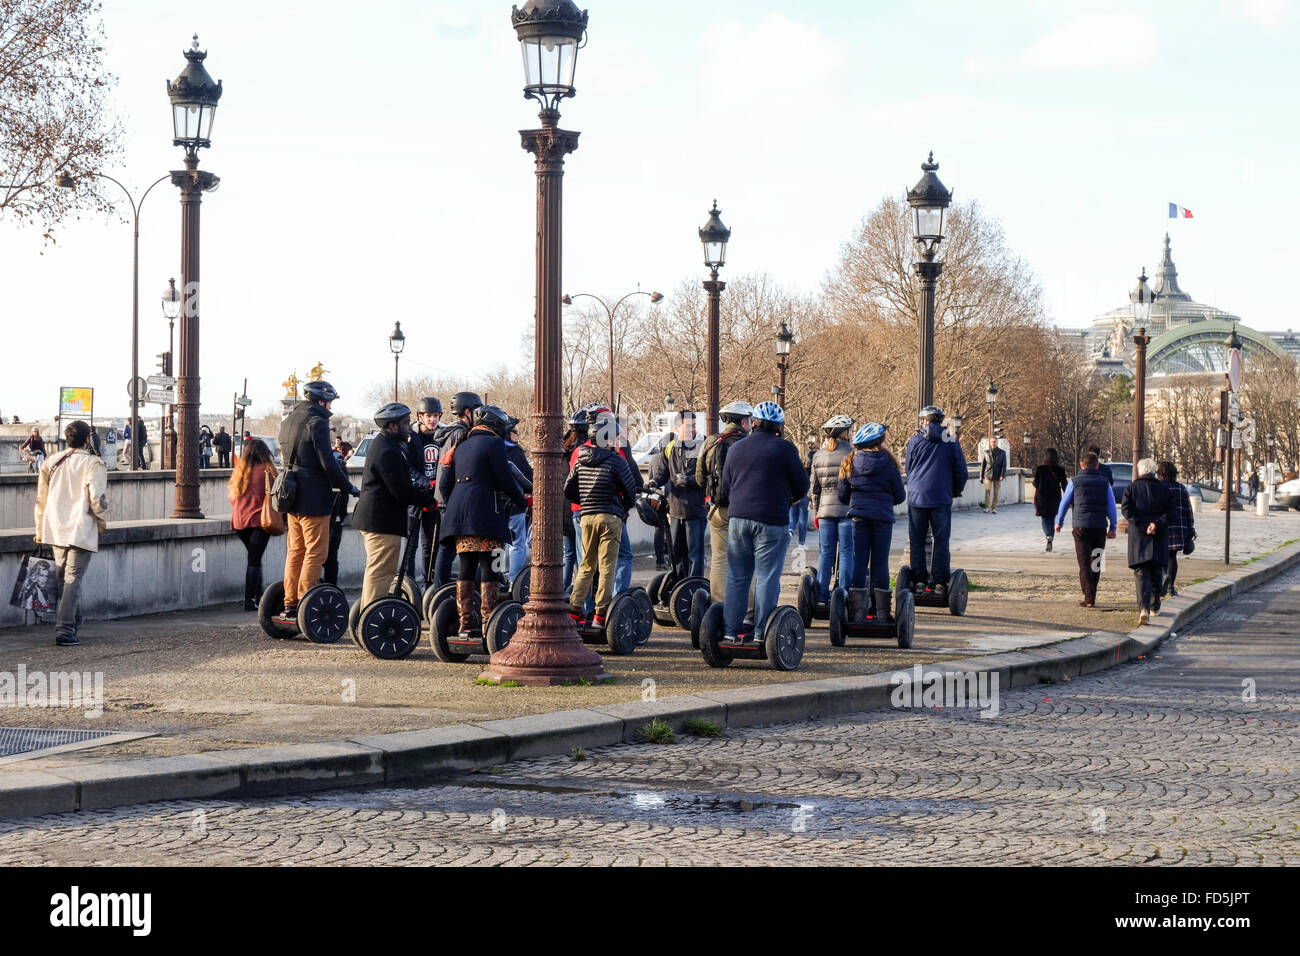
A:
[904,405,966,596]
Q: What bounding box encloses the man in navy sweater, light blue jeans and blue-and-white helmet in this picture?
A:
[715,402,809,640]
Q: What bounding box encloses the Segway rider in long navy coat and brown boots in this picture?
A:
[438,405,528,640]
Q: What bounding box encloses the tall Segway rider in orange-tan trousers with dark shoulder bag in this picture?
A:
[280,381,355,617]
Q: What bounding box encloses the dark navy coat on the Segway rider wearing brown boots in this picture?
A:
[438,428,528,541]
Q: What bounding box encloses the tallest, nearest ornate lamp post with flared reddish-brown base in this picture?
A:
[484,0,605,684]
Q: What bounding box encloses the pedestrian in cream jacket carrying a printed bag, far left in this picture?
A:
[35,421,108,648]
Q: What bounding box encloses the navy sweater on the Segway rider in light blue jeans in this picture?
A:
[716,428,809,528]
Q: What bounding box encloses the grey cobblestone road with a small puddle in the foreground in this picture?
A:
[0,571,1300,865]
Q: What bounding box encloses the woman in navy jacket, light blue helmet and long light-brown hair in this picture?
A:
[836,421,907,619]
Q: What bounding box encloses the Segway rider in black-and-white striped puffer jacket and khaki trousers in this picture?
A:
[564,408,637,627]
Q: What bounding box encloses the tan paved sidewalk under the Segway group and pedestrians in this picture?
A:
[0,506,1300,775]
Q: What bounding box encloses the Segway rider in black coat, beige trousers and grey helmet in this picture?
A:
[352,402,433,610]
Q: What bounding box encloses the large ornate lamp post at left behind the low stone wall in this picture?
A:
[166,34,221,518]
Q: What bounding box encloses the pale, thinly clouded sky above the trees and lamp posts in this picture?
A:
[0,0,1300,420]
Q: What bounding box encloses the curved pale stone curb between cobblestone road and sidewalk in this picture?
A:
[0,544,1300,819]
